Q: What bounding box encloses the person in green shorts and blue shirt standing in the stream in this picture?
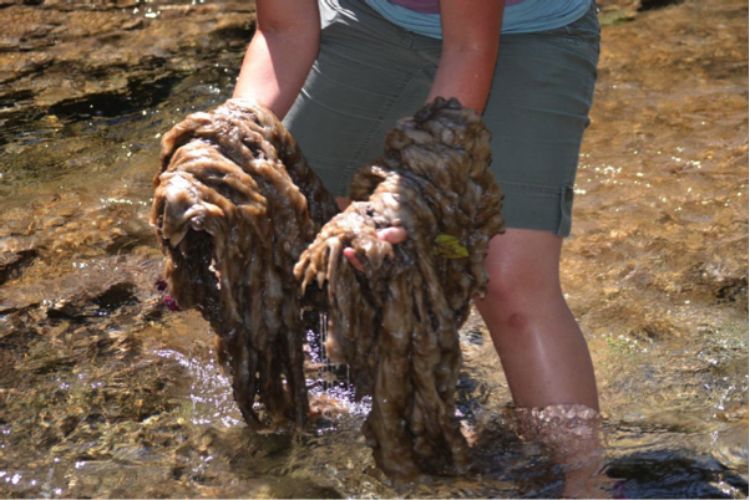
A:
[234,0,599,488]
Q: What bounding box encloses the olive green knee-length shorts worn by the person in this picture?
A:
[284,0,599,236]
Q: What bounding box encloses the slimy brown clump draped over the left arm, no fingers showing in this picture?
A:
[151,100,336,425]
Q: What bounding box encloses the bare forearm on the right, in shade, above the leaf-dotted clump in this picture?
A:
[427,0,505,113]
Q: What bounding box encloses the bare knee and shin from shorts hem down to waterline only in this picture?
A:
[476,229,599,410]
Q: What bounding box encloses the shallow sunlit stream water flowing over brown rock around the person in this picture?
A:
[0,0,748,497]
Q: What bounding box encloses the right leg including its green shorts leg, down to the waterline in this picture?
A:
[477,9,599,410]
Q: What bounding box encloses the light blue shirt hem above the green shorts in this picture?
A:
[365,0,593,39]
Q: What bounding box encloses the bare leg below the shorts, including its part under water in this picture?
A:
[476,229,604,497]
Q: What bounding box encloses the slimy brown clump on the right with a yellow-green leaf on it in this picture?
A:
[295,99,503,478]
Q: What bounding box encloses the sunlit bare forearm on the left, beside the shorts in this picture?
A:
[234,0,320,118]
